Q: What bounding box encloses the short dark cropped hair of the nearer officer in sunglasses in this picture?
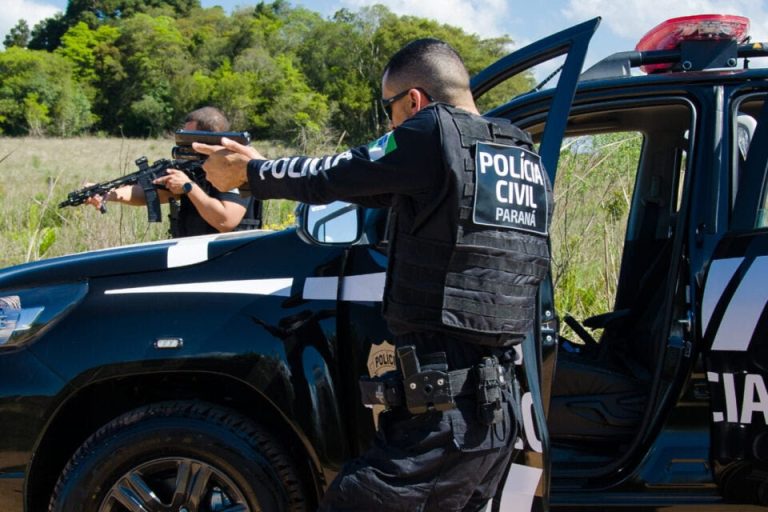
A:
[384,38,469,103]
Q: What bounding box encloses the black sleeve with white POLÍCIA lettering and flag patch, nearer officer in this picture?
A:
[243,109,442,207]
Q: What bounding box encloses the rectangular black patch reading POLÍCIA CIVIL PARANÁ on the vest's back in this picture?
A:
[472,142,549,235]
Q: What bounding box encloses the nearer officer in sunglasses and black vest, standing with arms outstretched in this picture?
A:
[194,39,552,511]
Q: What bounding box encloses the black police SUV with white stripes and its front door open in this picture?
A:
[0,15,768,512]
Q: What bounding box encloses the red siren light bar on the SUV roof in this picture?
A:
[635,14,749,73]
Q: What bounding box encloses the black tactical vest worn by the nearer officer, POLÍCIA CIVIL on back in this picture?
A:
[384,105,553,346]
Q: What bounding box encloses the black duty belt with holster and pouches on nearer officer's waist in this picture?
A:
[360,346,509,425]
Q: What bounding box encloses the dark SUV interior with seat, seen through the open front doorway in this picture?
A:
[527,99,694,467]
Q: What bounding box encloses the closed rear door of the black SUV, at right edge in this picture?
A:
[699,92,768,504]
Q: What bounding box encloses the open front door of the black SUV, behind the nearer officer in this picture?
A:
[471,18,600,512]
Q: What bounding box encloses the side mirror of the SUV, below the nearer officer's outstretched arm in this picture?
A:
[296,201,363,245]
